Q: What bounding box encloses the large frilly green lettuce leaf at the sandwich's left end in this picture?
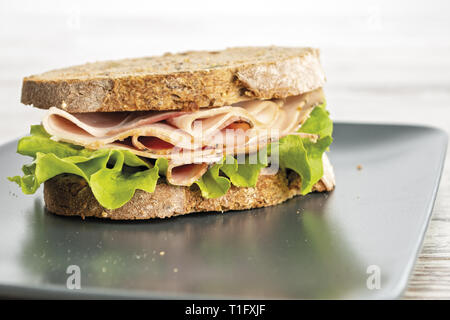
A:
[9,126,162,209]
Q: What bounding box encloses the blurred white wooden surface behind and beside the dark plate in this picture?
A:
[0,0,450,299]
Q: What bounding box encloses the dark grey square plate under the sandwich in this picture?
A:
[0,123,447,299]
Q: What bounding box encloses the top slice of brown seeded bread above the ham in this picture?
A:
[21,46,325,113]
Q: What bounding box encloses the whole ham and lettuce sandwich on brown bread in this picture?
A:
[9,46,335,220]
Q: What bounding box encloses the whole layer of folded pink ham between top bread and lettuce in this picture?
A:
[43,92,322,186]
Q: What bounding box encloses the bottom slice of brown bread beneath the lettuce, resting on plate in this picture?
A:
[44,170,332,220]
